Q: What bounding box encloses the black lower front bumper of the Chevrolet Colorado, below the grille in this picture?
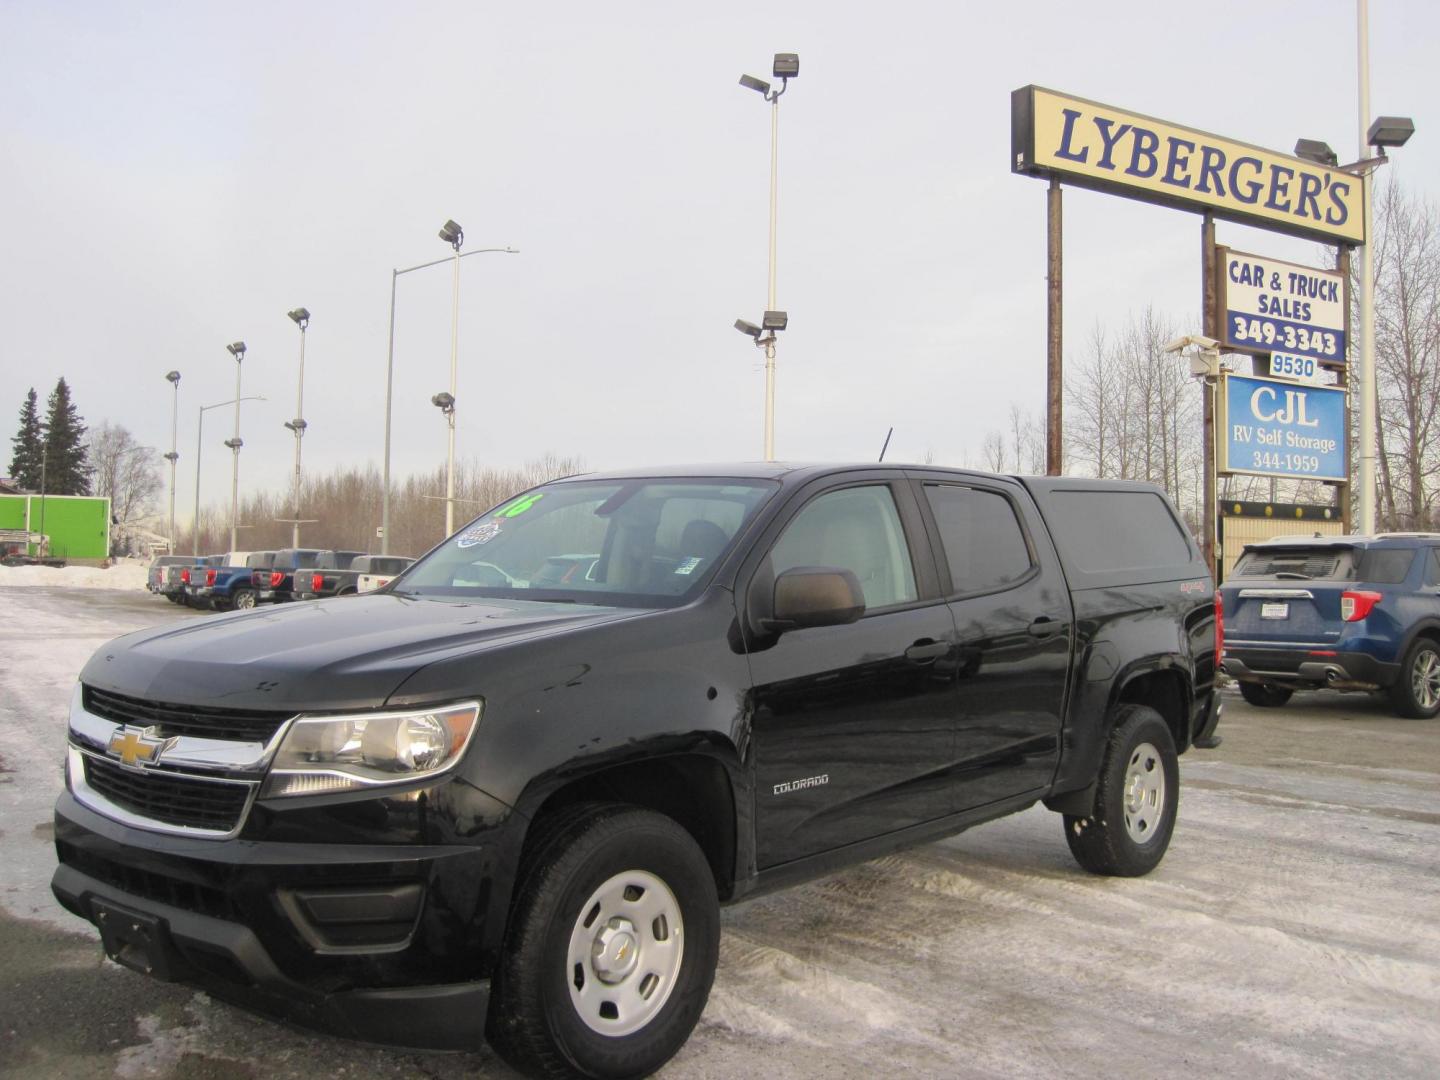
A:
[50,793,503,1050]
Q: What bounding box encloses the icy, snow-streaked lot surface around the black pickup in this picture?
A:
[0,588,1440,1080]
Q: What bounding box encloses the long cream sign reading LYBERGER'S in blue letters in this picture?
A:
[1011,86,1365,243]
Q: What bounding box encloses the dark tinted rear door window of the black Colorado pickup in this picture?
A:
[924,484,1031,593]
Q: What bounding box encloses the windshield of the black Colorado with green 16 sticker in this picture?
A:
[395,480,778,606]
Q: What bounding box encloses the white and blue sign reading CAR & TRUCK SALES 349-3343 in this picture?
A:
[1218,248,1345,365]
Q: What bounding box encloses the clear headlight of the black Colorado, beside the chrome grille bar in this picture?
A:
[261,701,484,799]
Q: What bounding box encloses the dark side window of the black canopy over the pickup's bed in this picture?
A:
[1047,490,1191,573]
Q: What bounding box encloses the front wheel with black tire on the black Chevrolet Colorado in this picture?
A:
[487,805,720,1079]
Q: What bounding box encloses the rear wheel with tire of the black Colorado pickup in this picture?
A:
[1064,706,1179,877]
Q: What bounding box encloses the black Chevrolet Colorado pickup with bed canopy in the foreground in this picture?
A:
[53,465,1220,1077]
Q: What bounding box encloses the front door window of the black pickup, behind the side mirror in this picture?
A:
[770,484,917,609]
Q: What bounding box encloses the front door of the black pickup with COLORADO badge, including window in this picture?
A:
[750,482,956,870]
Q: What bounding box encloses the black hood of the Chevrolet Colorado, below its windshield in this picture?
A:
[81,593,645,711]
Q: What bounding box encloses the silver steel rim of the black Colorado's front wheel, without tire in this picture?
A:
[566,870,684,1035]
